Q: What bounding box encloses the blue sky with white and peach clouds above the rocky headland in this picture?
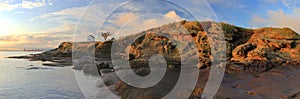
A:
[0,0,300,50]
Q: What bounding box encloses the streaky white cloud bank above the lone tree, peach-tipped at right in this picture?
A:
[30,3,182,41]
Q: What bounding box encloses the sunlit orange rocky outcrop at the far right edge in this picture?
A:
[231,28,300,64]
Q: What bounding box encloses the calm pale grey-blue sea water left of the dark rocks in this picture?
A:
[0,51,96,99]
